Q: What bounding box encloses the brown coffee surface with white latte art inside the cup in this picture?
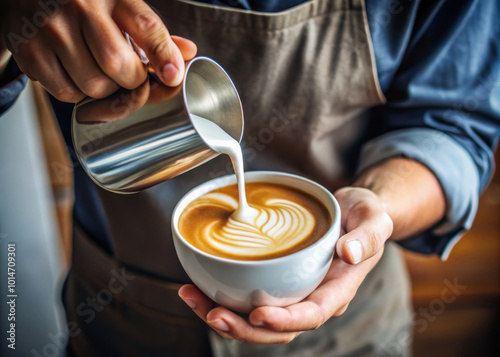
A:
[179,183,331,260]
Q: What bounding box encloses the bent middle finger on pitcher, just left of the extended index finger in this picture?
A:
[82,10,147,89]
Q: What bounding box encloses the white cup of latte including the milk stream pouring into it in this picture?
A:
[172,113,340,312]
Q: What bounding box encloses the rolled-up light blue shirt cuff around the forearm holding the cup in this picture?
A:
[358,128,480,259]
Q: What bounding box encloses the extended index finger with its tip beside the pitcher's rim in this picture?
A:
[113,0,185,87]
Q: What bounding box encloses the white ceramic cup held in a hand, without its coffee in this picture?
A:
[172,171,340,313]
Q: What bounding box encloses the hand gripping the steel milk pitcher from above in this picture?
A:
[1,0,196,102]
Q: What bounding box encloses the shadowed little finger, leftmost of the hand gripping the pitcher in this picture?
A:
[14,47,85,103]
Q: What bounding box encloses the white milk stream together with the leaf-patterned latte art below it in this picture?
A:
[191,114,315,256]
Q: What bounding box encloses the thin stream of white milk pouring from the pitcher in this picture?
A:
[190,114,259,222]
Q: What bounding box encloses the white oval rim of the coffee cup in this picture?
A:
[172,171,341,265]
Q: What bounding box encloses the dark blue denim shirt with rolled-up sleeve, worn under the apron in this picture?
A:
[0,0,500,258]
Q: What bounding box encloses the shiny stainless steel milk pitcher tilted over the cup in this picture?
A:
[71,57,243,193]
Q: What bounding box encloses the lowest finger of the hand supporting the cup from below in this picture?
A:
[207,307,301,344]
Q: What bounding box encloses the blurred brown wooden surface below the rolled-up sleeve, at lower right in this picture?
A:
[404,150,500,357]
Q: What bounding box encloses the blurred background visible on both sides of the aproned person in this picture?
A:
[0,83,500,357]
